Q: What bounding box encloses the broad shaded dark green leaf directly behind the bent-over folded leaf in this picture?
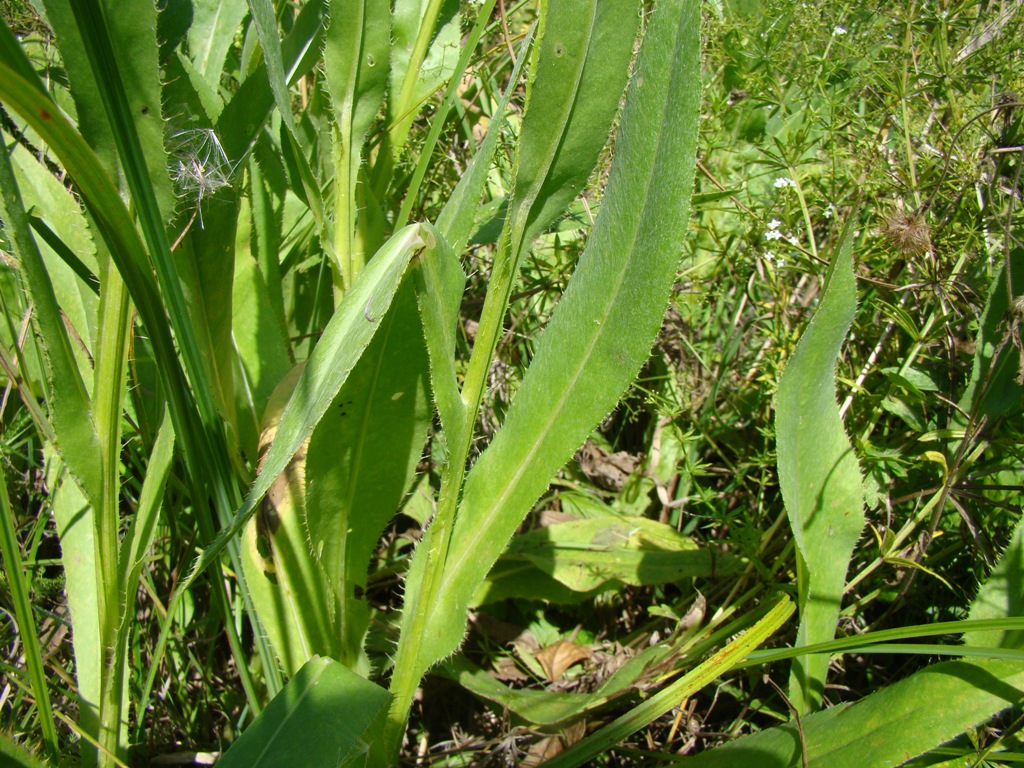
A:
[305,274,432,671]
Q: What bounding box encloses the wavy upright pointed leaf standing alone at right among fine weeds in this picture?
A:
[775,214,864,713]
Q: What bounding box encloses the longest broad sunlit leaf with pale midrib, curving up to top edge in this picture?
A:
[404,0,700,684]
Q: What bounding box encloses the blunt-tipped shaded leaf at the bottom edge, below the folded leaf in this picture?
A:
[217,658,388,768]
